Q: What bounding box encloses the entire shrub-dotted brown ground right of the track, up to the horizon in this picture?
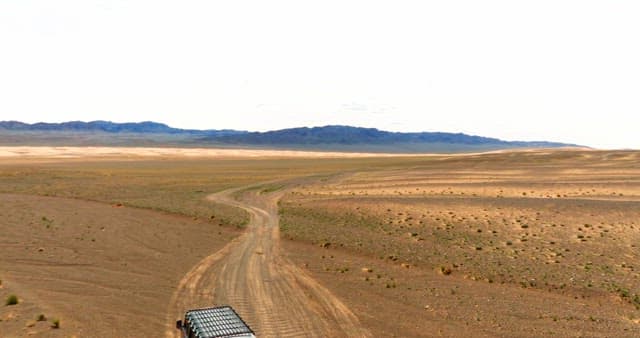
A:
[280,152,640,337]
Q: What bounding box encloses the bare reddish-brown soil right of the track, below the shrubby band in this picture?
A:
[283,241,640,337]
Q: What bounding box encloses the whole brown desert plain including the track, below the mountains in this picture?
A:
[0,147,640,337]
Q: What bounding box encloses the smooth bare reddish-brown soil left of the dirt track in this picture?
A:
[0,194,238,337]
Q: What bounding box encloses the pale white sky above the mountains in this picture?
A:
[0,0,640,149]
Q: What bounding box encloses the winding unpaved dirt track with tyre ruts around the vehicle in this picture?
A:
[167,182,371,337]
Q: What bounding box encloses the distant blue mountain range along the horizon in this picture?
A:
[0,121,576,152]
